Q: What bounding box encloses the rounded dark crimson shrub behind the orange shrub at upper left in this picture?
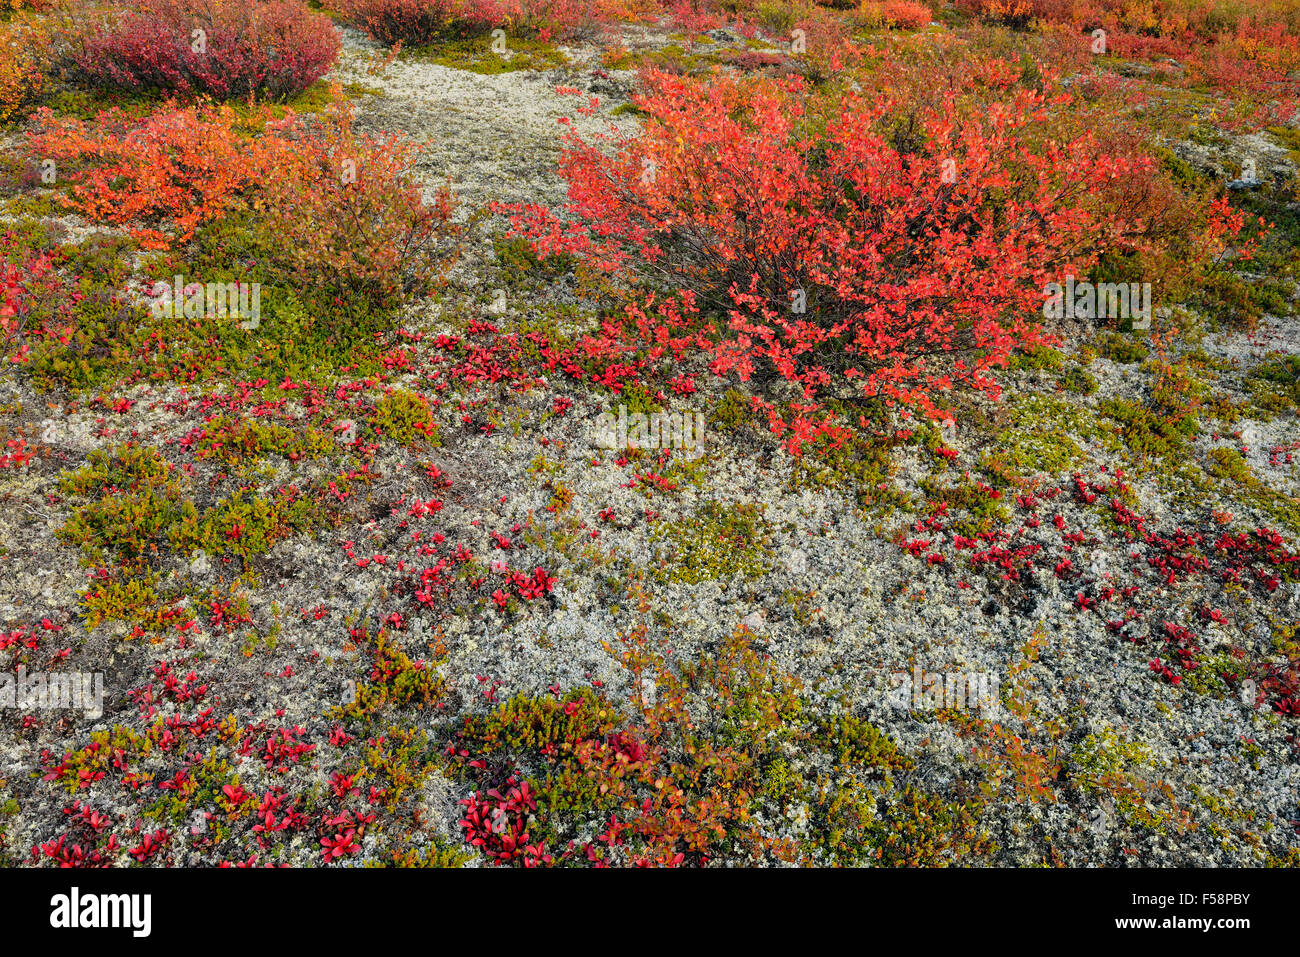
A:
[70,0,339,99]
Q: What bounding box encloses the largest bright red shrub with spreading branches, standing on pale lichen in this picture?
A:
[502,64,1237,443]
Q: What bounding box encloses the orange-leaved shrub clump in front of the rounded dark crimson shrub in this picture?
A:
[29,88,451,303]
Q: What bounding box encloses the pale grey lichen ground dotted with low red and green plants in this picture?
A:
[0,14,1300,866]
